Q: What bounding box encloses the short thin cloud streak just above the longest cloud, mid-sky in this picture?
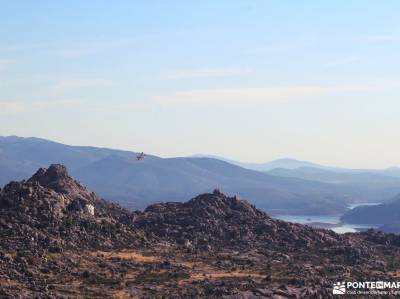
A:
[161,68,251,80]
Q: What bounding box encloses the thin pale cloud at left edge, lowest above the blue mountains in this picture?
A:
[0,99,82,115]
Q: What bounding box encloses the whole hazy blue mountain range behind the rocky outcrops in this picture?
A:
[0,136,400,215]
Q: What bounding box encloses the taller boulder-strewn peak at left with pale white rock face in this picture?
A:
[0,165,143,252]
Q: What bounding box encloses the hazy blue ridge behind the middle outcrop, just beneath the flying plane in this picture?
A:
[73,157,354,213]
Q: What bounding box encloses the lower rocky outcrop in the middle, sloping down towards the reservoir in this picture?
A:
[135,190,344,250]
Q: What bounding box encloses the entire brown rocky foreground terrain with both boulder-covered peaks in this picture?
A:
[0,165,400,299]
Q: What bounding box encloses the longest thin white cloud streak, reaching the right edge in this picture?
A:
[155,81,400,104]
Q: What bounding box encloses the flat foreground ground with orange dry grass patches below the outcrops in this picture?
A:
[0,245,399,298]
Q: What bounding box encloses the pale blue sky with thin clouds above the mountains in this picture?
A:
[0,0,400,168]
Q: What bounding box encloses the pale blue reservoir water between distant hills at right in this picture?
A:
[272,203,379,234]
